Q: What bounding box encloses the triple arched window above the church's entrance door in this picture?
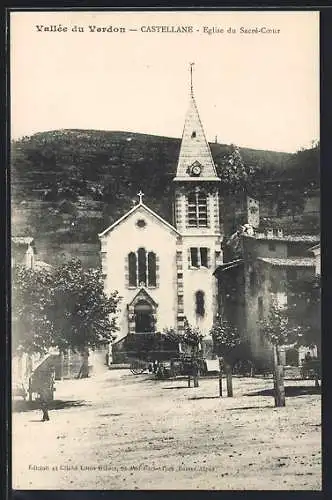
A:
[128,248,157,287]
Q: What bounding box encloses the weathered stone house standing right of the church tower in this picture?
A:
[214,229,320,365]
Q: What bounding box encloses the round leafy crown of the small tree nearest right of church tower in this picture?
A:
[210,317,241,359]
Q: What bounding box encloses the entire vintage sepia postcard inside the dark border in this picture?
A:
[9,10,322,491]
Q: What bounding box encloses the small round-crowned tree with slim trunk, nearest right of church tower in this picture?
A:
[210,318,241,397]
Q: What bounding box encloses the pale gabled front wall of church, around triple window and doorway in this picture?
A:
[101,207,177,340]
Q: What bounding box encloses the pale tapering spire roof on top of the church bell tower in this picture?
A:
[174,93,220,181]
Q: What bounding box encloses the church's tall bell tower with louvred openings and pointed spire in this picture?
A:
[173,63,222,334]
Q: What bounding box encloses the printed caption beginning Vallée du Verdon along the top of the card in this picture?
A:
[35,24,280,35]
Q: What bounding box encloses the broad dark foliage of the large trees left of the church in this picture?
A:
[12,260,119,352]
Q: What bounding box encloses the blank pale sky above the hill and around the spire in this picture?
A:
[10,11,319,152]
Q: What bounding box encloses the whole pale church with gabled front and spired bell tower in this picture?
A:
[99,72,223,350]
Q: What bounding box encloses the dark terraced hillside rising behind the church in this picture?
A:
[11,130,319,268]
